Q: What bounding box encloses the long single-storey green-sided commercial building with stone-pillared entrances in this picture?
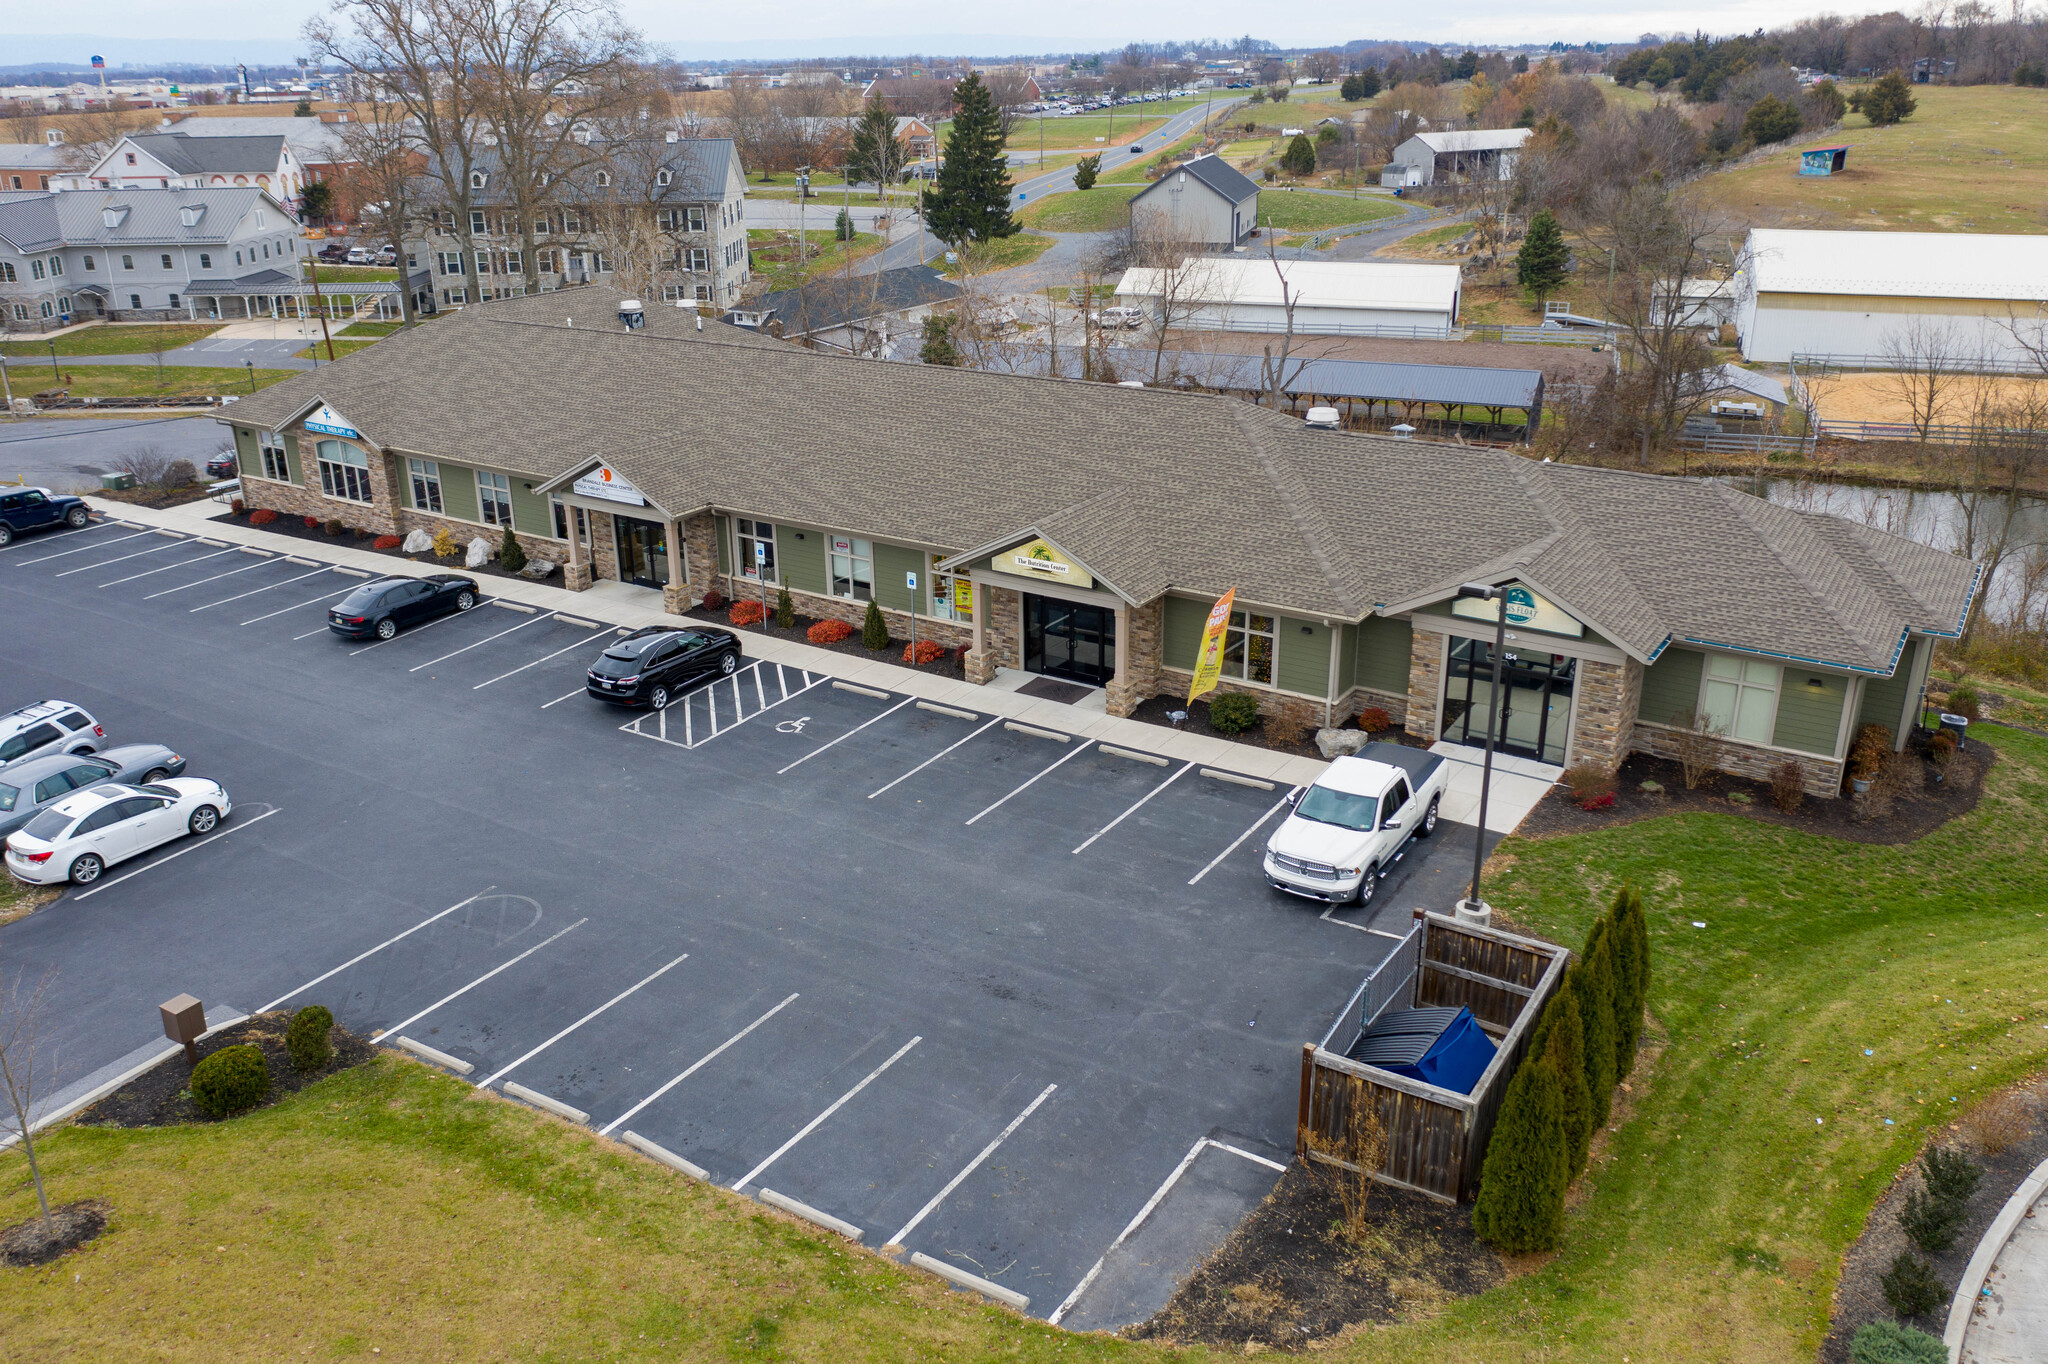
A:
[219,289,1976,795]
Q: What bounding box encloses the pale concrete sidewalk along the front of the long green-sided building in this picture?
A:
[75,498,1548,834]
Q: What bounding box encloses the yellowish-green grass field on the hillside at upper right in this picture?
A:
[1706,86,2048,231]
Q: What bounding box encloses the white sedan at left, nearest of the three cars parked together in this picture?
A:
[6,776,233,885]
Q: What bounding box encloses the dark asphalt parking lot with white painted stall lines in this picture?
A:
[0,509,1473,1327]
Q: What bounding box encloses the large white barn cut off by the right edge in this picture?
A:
[1735,227,2048,363]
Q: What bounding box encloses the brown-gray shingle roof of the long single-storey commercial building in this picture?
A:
[223,289,1974,674]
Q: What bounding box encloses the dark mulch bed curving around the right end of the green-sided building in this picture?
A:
[1518,737,1997,844]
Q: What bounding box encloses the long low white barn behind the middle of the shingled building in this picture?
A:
[1116,256,1462,336]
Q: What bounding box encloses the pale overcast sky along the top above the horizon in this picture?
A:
[16,0,1862,61]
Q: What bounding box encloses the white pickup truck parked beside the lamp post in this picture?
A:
[1266,743,1450,905]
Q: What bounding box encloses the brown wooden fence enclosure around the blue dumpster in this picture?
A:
[1294,913,1571,1202]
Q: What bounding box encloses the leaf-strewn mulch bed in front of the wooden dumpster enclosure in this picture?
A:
[1124,1163,1505,1352]
